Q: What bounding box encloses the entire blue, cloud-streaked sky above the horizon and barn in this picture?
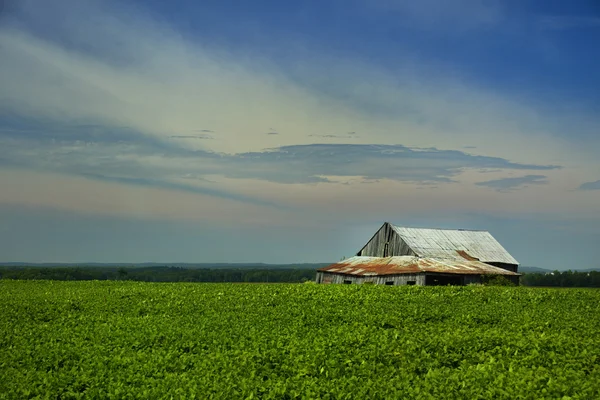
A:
[0,0,600,270]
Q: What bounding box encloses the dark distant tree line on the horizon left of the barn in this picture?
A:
[0,267,315,283]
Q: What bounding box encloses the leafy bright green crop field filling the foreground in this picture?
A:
[0,281,600,399]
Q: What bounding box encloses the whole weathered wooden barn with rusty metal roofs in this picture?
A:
[316,222,520,285]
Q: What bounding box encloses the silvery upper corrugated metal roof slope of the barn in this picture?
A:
[390,224,519,265]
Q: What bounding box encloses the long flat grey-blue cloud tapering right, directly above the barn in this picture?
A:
[228,144,560,183]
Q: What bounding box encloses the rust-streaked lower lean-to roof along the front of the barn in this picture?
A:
[318,256,520,276]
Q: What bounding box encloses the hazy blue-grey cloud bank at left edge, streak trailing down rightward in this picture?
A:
[0,118,275,206]
